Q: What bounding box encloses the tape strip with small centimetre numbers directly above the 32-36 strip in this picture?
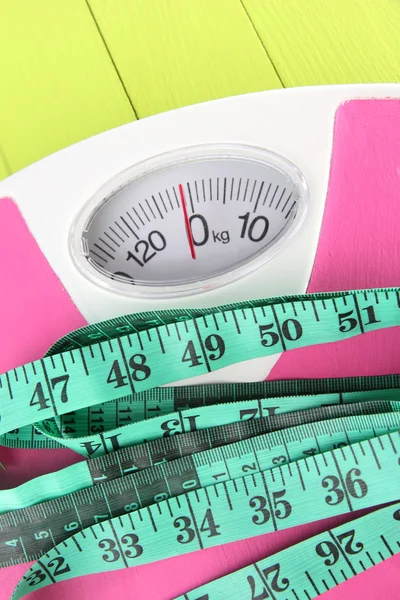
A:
[0,403,400,567]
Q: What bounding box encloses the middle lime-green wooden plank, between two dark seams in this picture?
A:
[88,0,281,117]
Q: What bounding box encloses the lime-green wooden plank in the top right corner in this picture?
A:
[243,0,400,86]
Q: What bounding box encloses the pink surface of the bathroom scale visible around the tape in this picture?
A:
[0,101,400,600]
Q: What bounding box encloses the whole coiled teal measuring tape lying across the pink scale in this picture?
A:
[0,289,400,600]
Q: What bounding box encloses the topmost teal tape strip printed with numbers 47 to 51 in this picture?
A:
[0,289,400,434]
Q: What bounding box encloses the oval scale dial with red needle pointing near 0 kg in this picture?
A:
[71,144,308,297]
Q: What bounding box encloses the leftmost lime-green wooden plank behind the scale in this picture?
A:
[0,0,135,171]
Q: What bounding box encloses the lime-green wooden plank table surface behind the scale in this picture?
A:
[0,0,400,178]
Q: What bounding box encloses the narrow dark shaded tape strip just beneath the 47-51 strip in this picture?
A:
[0,375,400,450]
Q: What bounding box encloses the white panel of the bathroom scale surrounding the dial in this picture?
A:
[0,84,400,384]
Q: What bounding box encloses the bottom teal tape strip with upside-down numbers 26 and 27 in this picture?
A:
[176,504,400,600]
